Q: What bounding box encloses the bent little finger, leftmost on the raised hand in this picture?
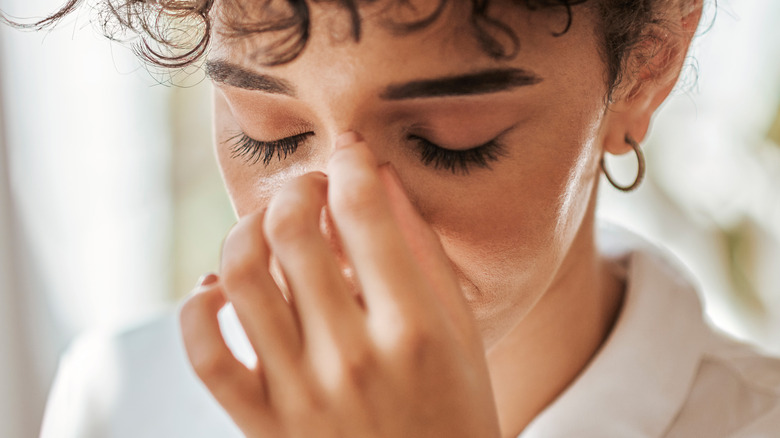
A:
[179,278,268,432]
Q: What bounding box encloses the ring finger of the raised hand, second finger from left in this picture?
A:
[221,212,302,380]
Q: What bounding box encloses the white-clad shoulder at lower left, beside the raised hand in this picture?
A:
[42,312,240,437]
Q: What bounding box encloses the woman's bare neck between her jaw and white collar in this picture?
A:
[487,215,625,437]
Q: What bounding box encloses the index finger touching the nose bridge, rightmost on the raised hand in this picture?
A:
[328,134,434,317]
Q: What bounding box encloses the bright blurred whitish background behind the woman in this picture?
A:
[0,0,780,437]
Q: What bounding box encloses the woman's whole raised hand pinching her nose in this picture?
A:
[180,134,499,438]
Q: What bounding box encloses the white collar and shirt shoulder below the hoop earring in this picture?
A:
[522,222,780,438]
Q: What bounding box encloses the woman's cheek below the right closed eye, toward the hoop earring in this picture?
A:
[416,113,598,302]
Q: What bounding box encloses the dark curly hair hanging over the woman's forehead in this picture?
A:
[0,0,679,96]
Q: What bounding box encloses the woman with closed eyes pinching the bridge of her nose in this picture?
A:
[10,0,780,438]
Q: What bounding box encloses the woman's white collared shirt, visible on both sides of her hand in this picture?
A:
[42,227,780,438]
